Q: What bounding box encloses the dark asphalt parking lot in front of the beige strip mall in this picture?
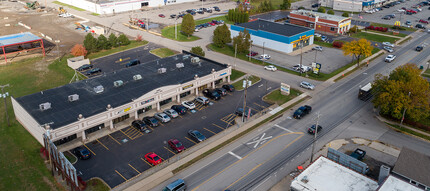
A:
[74,80,278,188]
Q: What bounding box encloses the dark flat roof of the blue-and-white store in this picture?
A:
[237,19,312,36]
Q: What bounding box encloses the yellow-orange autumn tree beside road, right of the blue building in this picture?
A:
[342,38,373,66]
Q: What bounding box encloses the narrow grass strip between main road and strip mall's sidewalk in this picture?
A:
[172,97,307,174]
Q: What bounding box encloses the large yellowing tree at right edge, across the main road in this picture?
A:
[372,64,430,121]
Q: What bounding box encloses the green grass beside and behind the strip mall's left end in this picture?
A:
[0,57,74,190]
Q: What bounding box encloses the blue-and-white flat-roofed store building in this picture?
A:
[230,19,314,53]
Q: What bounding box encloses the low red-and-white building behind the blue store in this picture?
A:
[290,10,351,34]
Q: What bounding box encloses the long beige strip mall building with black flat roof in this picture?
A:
[12,51,231,145]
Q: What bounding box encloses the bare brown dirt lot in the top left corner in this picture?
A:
[0,1,86,61]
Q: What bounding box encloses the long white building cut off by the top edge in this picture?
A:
[58,0,197,14]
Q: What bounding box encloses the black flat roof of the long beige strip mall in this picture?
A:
[16,51,228,129]
